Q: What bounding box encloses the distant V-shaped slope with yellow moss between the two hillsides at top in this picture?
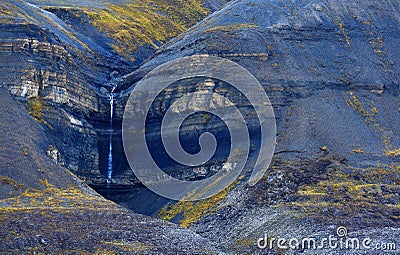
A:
[27,0,227,64]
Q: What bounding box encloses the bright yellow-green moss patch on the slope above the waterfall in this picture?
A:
[85,0,209,56]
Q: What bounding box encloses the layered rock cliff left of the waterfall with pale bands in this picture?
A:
[0,2,109,182]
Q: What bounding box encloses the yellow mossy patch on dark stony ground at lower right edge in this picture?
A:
[291,164,400,212]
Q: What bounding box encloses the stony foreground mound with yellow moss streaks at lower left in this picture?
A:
[0,89,217,254]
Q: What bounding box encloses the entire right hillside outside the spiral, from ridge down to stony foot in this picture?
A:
[120,0,400,252]
